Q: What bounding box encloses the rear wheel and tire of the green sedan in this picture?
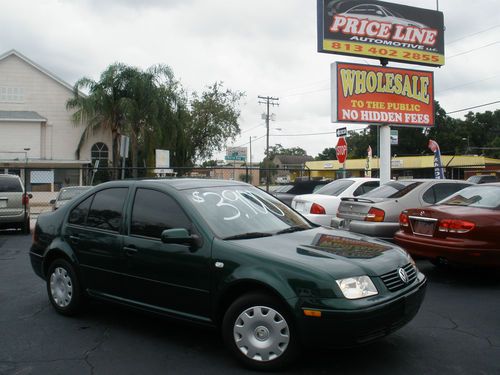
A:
[47,259,82,316]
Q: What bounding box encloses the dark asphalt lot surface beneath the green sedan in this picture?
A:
[0,231,500,375]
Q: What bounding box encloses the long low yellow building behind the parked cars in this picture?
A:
[306,155,500,179]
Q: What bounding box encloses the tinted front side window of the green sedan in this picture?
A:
[130,189,191,238]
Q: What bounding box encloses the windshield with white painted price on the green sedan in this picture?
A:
[184,185,312,239]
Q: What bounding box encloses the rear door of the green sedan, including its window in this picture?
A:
[63,187,128,297]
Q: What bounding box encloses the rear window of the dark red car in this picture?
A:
[437,186,500,210]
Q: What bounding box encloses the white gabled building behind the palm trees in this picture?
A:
[0,50,112,191]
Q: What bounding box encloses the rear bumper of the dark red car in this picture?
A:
[394,232,500,267]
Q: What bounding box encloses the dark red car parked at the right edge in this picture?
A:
[394,183,500,267]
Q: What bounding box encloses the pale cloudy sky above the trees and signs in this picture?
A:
[0,0,500,161]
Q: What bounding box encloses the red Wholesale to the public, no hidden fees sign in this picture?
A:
[331,63,434,127]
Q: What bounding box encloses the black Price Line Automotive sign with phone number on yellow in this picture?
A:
[317,0,444,66]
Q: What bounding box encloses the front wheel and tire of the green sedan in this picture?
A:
[222,294,298,370]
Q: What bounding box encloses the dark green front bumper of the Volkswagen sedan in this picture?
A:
[298,277,427,348]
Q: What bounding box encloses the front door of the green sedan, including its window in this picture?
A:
[124,187,211,318]
